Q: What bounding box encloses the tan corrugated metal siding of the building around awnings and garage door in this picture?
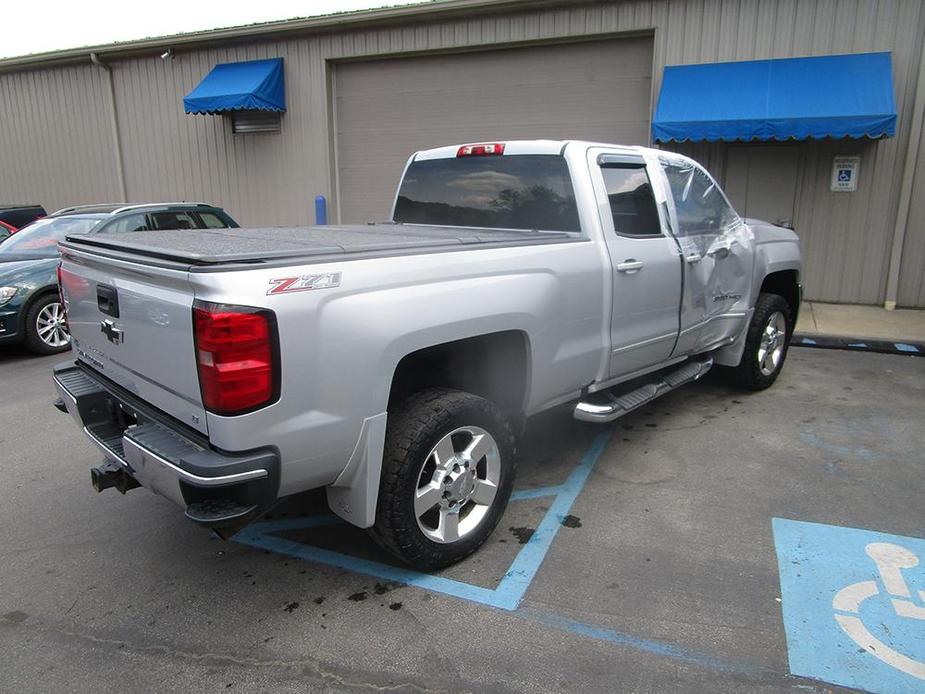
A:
[0,0,925,305]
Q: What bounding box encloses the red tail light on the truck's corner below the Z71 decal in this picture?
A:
[193,301,279,416]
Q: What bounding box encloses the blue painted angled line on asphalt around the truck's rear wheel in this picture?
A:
[234,431,611,610]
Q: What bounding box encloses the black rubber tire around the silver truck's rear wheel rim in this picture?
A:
[370,388,514,571]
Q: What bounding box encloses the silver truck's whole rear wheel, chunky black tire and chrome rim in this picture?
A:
[372,388,514,571]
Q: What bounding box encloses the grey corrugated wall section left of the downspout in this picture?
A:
[0,65,119,212]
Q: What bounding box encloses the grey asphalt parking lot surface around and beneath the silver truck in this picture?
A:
[0,348,925,692]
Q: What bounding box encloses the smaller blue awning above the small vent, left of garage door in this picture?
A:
[183,58,286,113]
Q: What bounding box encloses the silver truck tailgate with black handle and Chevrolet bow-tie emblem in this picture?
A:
[61,249,207,433]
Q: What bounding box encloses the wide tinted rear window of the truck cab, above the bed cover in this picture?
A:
[393,154,581,231]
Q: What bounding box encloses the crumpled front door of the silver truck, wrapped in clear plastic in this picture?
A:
[660,153,754,356]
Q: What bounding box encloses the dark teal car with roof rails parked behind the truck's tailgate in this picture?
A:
[0,203,238,354]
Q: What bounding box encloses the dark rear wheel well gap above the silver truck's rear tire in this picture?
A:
[389,330,528,416]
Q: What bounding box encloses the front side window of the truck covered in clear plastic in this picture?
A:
[661,159,739,236]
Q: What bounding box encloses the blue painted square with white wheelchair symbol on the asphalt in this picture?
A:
[773,518,925,692]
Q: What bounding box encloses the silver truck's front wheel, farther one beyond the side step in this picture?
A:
[733,294,793,390]
